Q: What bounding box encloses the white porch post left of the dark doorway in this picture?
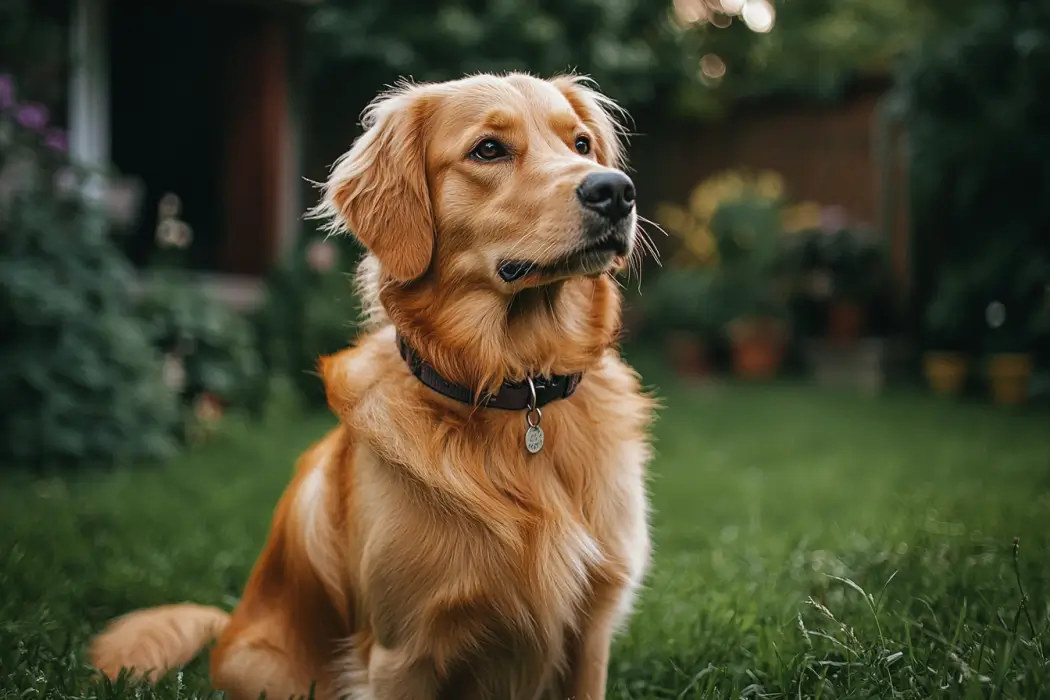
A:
[69,0,109,168]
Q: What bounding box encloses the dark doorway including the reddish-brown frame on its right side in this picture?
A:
[109,0,289,275]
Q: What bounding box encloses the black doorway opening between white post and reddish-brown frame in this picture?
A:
[109,0,232,270]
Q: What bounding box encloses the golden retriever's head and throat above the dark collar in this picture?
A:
[314,75,636,388]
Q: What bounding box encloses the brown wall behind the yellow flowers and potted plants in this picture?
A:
[631,86,910,309]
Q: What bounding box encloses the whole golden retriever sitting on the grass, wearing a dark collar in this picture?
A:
[90,73,654,700]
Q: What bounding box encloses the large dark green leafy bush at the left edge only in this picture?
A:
[0,77,180,466]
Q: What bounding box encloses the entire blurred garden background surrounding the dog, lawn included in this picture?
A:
[0,0,1050,699]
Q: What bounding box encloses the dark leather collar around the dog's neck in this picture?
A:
[397,334,583,410]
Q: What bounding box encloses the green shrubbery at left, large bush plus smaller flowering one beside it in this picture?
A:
[0,68,275,465]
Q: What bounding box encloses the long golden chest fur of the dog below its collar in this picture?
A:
[331,335,649,697]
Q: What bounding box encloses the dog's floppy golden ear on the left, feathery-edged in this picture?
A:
[310,87,434,282]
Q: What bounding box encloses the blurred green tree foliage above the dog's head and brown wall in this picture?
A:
[310,0,944,116]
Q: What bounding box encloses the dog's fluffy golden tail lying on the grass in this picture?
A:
[88,602,230,680]
